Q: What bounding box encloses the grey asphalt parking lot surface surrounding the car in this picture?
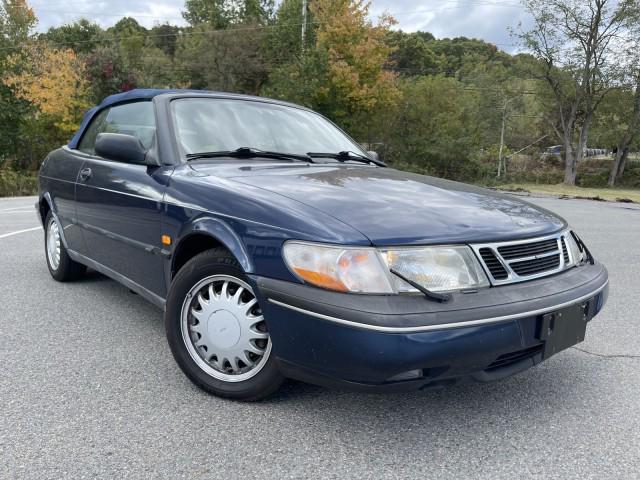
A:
[0,193,640,479]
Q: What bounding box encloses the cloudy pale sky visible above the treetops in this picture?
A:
[29,0,530,51]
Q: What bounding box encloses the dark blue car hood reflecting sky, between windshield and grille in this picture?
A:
[193,164,566,246]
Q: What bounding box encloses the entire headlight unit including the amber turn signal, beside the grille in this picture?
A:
[283,241,489,294]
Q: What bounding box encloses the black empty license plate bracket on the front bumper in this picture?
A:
[537,300,593,359]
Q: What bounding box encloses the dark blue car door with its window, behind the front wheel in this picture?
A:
[76,101,166,297]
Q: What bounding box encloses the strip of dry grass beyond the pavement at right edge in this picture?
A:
[496,183,640,203]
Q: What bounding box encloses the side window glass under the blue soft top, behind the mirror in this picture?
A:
[78,101,156,155]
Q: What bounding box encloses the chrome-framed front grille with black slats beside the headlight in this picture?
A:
[471,231,573,285]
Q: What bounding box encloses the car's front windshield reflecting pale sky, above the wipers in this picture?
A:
[172,98,364,158]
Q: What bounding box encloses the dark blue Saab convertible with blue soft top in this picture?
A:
[37,90,608,400]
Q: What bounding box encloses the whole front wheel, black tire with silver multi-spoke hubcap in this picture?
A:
[165,248,284,401]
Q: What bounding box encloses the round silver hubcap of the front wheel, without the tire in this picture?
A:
[181,275,271,382]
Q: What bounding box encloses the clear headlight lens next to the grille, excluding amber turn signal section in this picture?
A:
[382,246,489,292]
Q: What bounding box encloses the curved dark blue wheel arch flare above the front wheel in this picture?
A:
[172,214,255,273]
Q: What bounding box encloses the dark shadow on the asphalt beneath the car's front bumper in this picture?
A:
[263,351,597,423]
